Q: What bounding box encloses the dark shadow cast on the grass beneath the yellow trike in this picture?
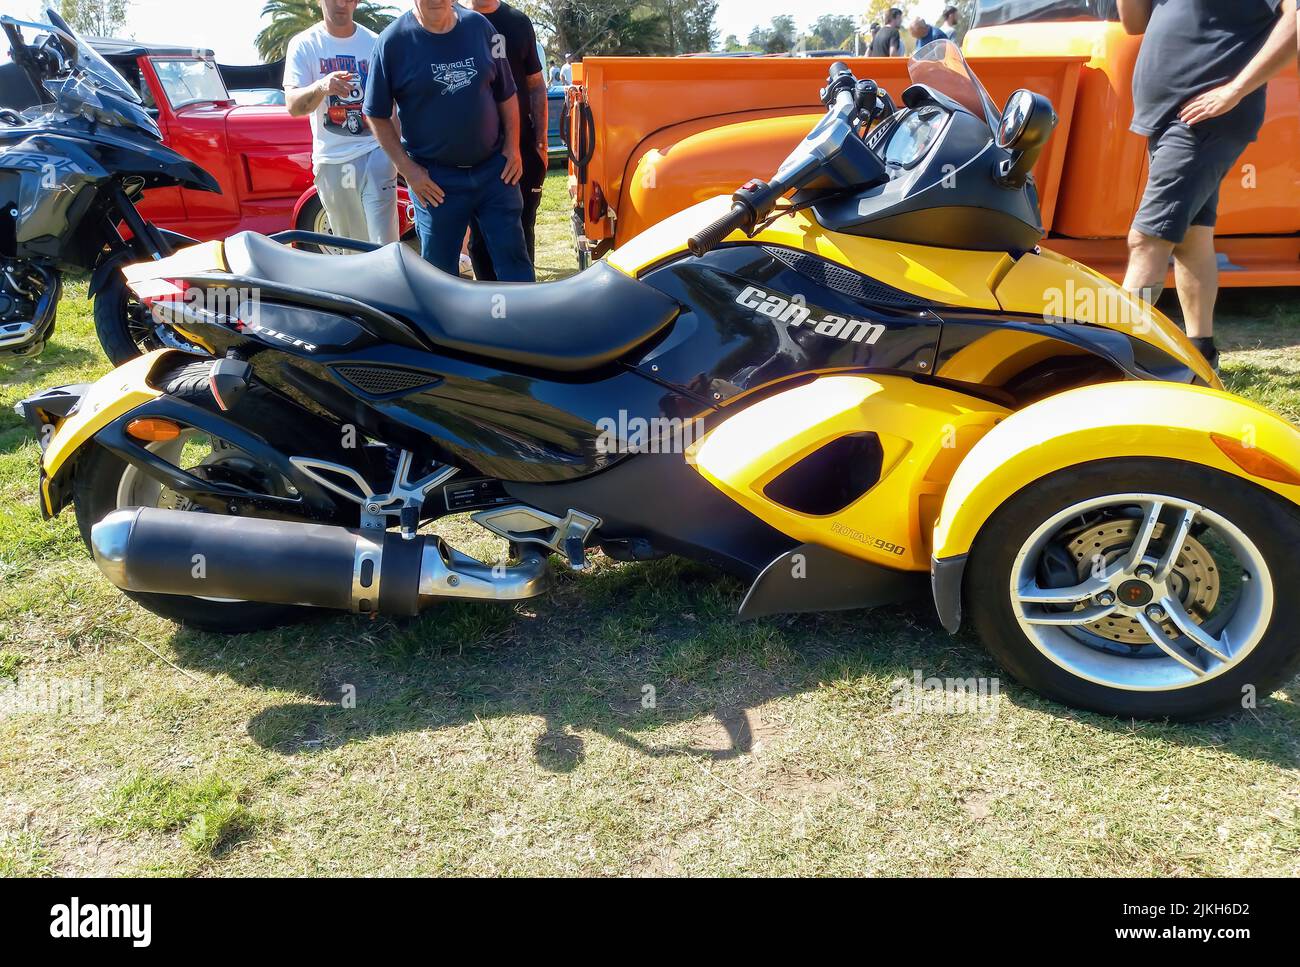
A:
[162,559,1300,772]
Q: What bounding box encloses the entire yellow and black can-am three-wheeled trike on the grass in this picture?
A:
[22,43,1300,717]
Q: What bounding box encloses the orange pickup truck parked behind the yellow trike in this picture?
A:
[567,0,1300,286]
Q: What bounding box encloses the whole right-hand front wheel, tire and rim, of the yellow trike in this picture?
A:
[966,459,1300,719]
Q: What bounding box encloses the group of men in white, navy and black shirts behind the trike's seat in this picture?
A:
[285,0,546,282]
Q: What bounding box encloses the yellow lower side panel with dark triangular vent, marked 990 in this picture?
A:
[686,376,1008,571]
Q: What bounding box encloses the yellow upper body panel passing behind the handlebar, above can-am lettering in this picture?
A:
[606,196,1013,311]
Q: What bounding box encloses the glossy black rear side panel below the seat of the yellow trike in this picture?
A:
[159,288,709,482]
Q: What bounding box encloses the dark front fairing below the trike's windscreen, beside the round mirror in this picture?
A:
[813,102,1043,252]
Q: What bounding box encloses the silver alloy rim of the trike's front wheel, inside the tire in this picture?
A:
[1010,494,1274,691]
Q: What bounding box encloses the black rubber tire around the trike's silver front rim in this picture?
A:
[963,459,1300,720]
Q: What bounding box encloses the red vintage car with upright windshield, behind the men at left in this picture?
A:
[90,39,413,249]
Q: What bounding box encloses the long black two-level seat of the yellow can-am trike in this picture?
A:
[225,231,680,372]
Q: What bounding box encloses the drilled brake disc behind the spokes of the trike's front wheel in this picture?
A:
[1067,517,1219,646]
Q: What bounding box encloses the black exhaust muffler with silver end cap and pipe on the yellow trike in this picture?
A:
[91,507,549,615]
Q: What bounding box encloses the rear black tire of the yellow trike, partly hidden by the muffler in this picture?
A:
[73,360,345,634]
